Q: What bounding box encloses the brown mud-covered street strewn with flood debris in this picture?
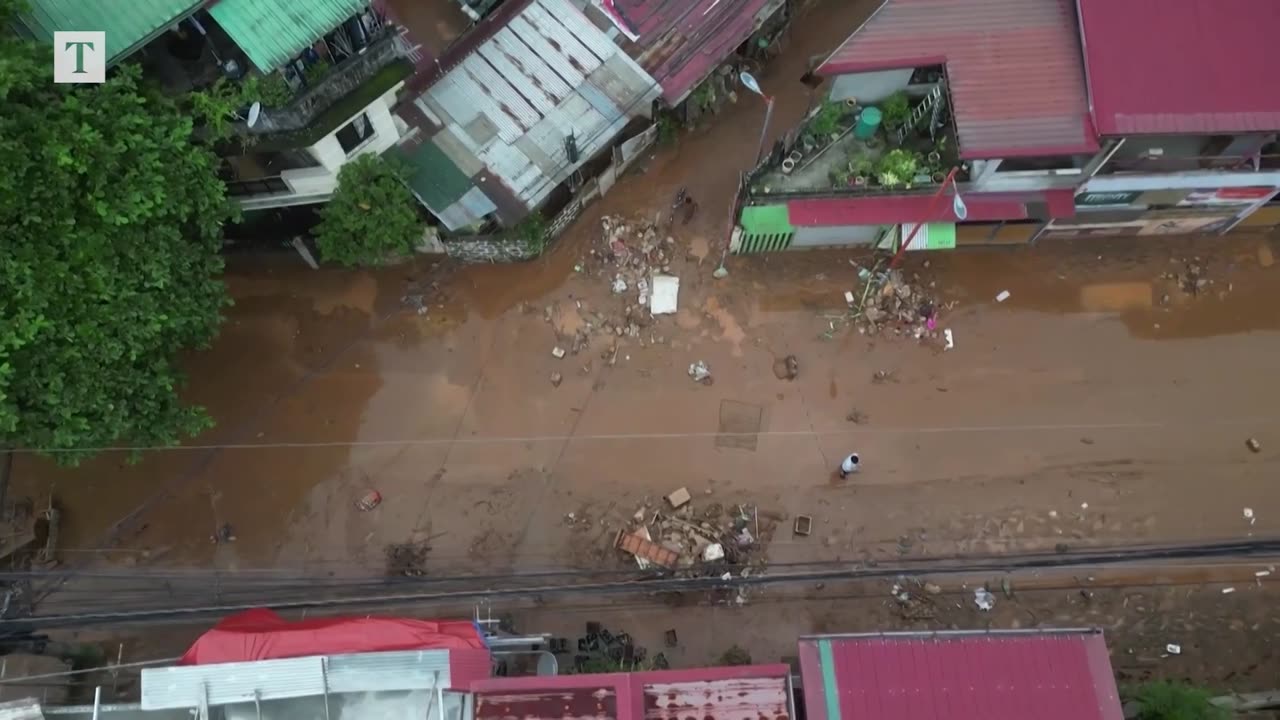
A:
[10,0,1280,687]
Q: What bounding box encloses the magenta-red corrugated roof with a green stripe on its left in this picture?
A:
[800,630,1124,720]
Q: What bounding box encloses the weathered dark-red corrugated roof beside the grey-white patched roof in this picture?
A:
[603,0,768,105]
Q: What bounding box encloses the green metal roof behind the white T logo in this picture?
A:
[18,0,201,63]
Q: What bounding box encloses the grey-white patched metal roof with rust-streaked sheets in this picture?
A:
[420,0,659,217]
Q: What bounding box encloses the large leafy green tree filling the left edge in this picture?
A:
[0,20,233,462]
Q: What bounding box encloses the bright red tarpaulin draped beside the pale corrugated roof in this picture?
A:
[179,610,485,665]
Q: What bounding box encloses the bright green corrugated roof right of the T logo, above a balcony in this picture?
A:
[209,0,369,73]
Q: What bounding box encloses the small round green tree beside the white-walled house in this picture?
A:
[316,152,422,266]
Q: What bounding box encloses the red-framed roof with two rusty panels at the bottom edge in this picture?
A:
[471,665,791,720]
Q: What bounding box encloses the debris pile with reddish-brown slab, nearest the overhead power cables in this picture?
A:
[614,488,786,580]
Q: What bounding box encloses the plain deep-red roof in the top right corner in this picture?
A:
[1079,0,1280,136]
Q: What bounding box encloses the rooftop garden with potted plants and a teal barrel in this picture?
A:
[750,91,966,196]
